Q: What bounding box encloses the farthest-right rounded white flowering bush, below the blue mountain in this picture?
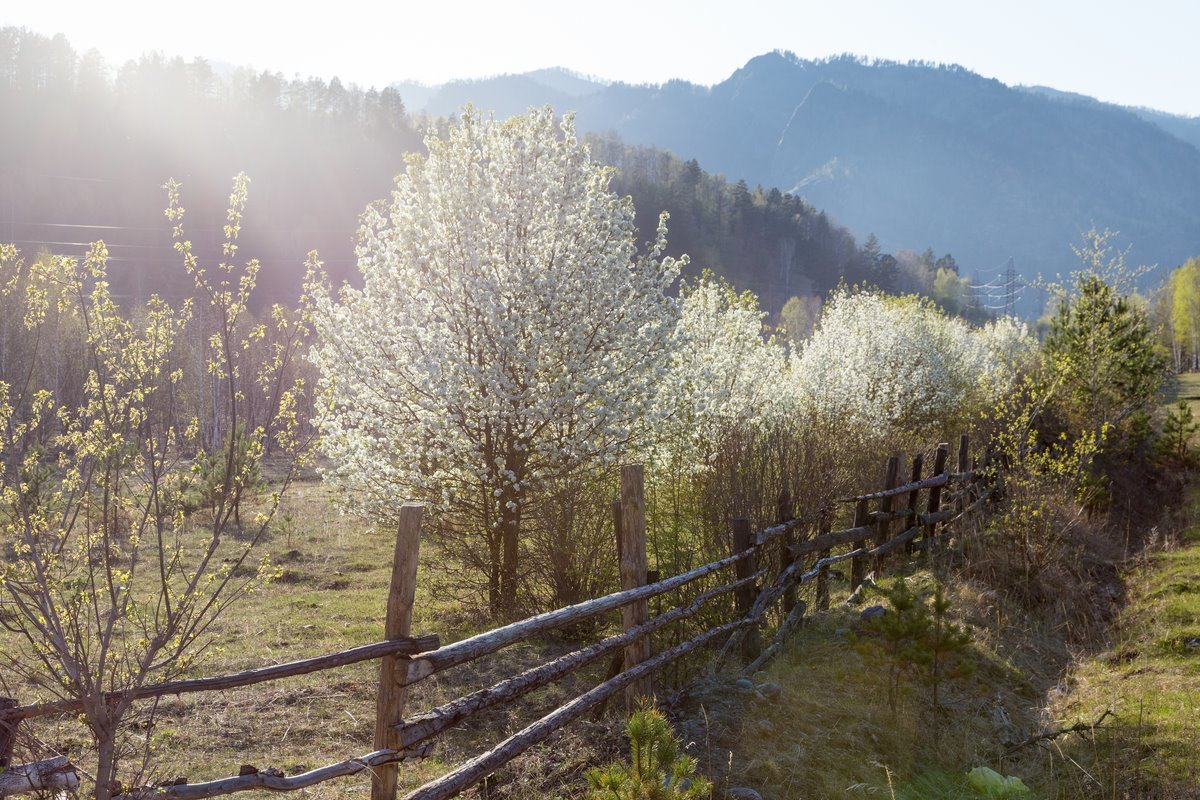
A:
[794,289,1037,438]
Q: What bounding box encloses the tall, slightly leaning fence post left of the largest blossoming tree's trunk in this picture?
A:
[371,503,425,800]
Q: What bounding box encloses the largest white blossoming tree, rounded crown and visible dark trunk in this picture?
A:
[313,109,679,613]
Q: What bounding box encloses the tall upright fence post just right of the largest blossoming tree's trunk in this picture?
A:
[619,464,653,711]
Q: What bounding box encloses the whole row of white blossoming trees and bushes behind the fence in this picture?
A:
[311,109,1032,612]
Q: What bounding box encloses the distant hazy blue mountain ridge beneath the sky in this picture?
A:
[400,53,1200,299]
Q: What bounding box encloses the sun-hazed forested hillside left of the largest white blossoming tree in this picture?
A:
[0,28,420,301]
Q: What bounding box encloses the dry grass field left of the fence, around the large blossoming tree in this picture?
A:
[7,480,619,798]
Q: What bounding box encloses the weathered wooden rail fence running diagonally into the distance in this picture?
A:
[0,435,998,800]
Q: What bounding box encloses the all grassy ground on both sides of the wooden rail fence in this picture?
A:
[9,380,1200,800]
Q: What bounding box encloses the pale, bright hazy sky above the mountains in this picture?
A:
[9,0,1200,115]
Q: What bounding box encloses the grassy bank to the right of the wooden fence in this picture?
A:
[686,375,1200,800]
